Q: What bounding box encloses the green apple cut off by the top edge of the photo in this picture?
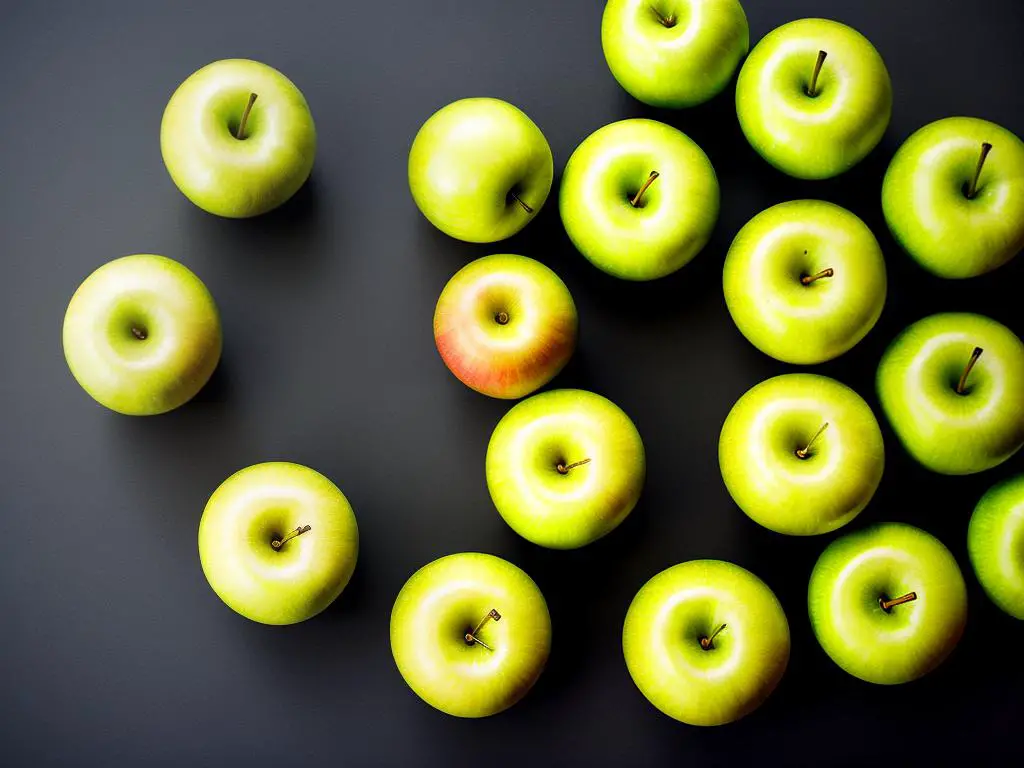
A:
[601,0,751,108]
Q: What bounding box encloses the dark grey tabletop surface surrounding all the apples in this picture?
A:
[0,0,1024,767]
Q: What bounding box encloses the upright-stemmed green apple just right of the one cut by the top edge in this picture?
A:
[736,18,893,179]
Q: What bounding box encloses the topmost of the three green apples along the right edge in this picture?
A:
[882,118,1024,278]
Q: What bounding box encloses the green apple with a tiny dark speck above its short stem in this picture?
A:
[722,200,886,366]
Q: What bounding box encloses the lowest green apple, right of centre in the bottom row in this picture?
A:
[623,560,790,725]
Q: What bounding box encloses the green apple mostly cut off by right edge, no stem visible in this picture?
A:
[967,474,1024,618]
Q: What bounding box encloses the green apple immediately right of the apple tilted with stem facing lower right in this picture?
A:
[558,119,719,281]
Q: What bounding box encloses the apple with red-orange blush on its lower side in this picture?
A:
[434,254,579,399]
